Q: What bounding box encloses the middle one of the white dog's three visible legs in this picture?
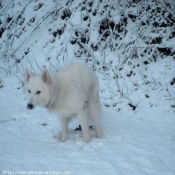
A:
[78,109,91,143]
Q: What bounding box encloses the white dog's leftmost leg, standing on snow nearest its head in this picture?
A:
[57,116,68,142]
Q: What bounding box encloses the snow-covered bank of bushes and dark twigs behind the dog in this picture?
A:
[0,0,175,111]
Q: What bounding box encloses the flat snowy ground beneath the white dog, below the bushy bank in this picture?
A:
[0,77,175,175]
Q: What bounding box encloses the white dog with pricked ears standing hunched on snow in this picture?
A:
[24,64,102,142]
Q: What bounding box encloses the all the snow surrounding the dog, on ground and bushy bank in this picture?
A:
[0,0,175,175]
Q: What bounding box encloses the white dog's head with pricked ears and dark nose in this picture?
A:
[24,69,51,109]
